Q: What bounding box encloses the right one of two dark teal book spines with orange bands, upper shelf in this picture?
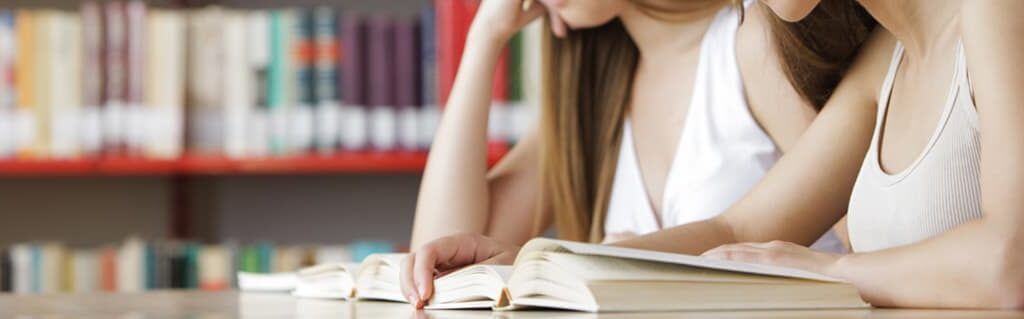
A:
[312,6,341,155]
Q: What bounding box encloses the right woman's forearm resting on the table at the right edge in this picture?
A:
[826,221,1022,308]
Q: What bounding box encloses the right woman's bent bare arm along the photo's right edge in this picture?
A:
[819,0,1024,309]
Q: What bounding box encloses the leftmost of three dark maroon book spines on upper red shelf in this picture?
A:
[79,1,106,157]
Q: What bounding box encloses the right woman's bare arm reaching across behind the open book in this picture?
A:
[617,32,894,255]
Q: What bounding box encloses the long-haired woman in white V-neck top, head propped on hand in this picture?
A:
[402,0,873,306]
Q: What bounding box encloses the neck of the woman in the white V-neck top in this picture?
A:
[620,0,727,61]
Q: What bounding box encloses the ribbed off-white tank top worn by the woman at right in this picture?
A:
[848,44,982,252]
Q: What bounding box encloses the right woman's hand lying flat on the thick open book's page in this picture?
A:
[702,240,842,277]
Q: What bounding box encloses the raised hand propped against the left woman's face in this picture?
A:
[470,0,568,45]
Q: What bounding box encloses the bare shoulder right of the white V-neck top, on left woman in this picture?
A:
[736,5,816,152]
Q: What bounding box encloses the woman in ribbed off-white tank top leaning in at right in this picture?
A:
[407,0,1024,309]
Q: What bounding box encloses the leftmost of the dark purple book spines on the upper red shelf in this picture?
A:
[340,14,369,150]
